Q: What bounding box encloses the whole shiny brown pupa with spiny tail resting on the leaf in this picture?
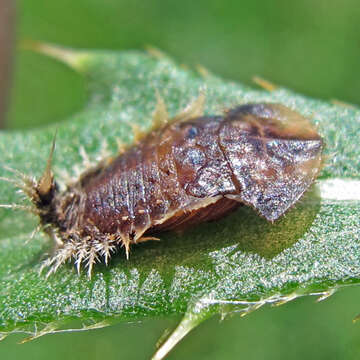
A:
[2,94,323,276]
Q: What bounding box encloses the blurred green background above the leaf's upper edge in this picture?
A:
[7,0,360,128]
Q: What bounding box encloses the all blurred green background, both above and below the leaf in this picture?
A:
[0,0,360,360]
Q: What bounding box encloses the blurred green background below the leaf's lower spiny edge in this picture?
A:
[4,287,360,360]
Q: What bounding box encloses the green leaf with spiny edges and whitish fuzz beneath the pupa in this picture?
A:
[0,46,360,359]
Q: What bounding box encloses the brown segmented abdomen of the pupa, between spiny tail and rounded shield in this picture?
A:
[81,117,237,241]
